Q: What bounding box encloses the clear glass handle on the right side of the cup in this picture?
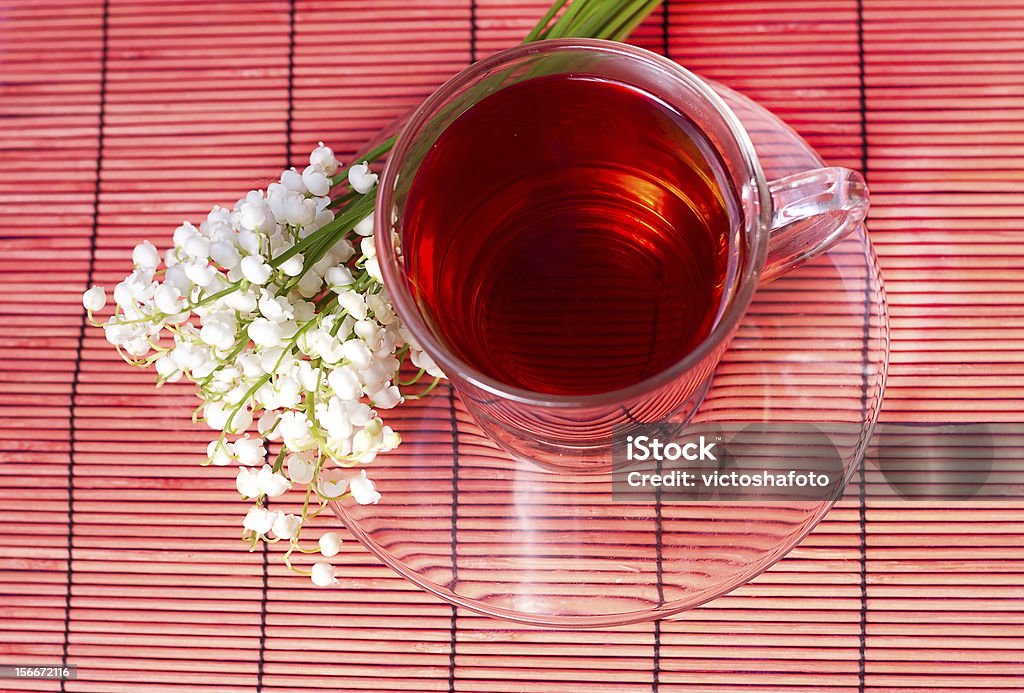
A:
[761,167,868,284]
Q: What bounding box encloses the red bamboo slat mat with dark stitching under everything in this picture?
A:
[0,0,1024,693]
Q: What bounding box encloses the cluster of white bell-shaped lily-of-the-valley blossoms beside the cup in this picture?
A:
[83,142,442,586]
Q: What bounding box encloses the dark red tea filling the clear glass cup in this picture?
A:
[403,75,734,395]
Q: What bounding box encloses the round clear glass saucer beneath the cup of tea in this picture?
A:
[332,80,889,629]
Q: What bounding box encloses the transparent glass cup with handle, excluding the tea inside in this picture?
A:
[375,39,867,473]
